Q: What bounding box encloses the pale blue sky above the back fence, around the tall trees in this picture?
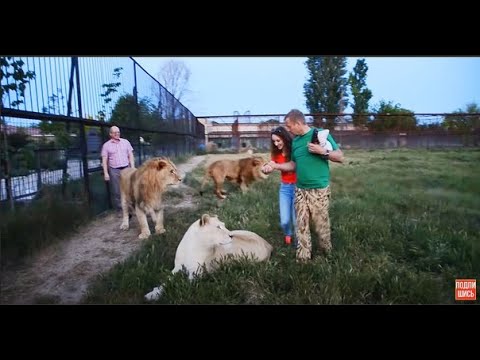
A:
[134,57,480,117]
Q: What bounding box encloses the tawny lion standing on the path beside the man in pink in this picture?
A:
[120,157,182,239]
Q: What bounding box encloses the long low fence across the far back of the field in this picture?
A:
[199,113,480,150]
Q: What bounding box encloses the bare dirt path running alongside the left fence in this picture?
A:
[0,155,206,304]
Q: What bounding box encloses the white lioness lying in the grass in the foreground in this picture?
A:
[145,214,273,300]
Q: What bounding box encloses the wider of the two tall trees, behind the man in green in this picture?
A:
[303,56,348,129]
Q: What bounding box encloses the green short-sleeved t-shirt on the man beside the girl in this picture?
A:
[292,128,338,189]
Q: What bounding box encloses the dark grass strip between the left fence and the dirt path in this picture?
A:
[0,155,196,267]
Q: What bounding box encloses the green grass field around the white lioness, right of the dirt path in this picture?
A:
[85,149,480,304]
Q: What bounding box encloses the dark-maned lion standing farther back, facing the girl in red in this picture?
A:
[200,156,268,199]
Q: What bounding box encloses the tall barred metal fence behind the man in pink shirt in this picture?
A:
[0,57,205,212]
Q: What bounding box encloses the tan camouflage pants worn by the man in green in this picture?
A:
[295,186,332,261]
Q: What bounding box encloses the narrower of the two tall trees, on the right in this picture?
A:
[348,59,372,127]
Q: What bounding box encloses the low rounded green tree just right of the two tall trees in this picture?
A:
[367,100,417,131]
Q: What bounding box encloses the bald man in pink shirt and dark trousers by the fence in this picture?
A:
[102,126,135,210]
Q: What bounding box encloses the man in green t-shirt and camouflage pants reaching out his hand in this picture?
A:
[264,109,343,261]
